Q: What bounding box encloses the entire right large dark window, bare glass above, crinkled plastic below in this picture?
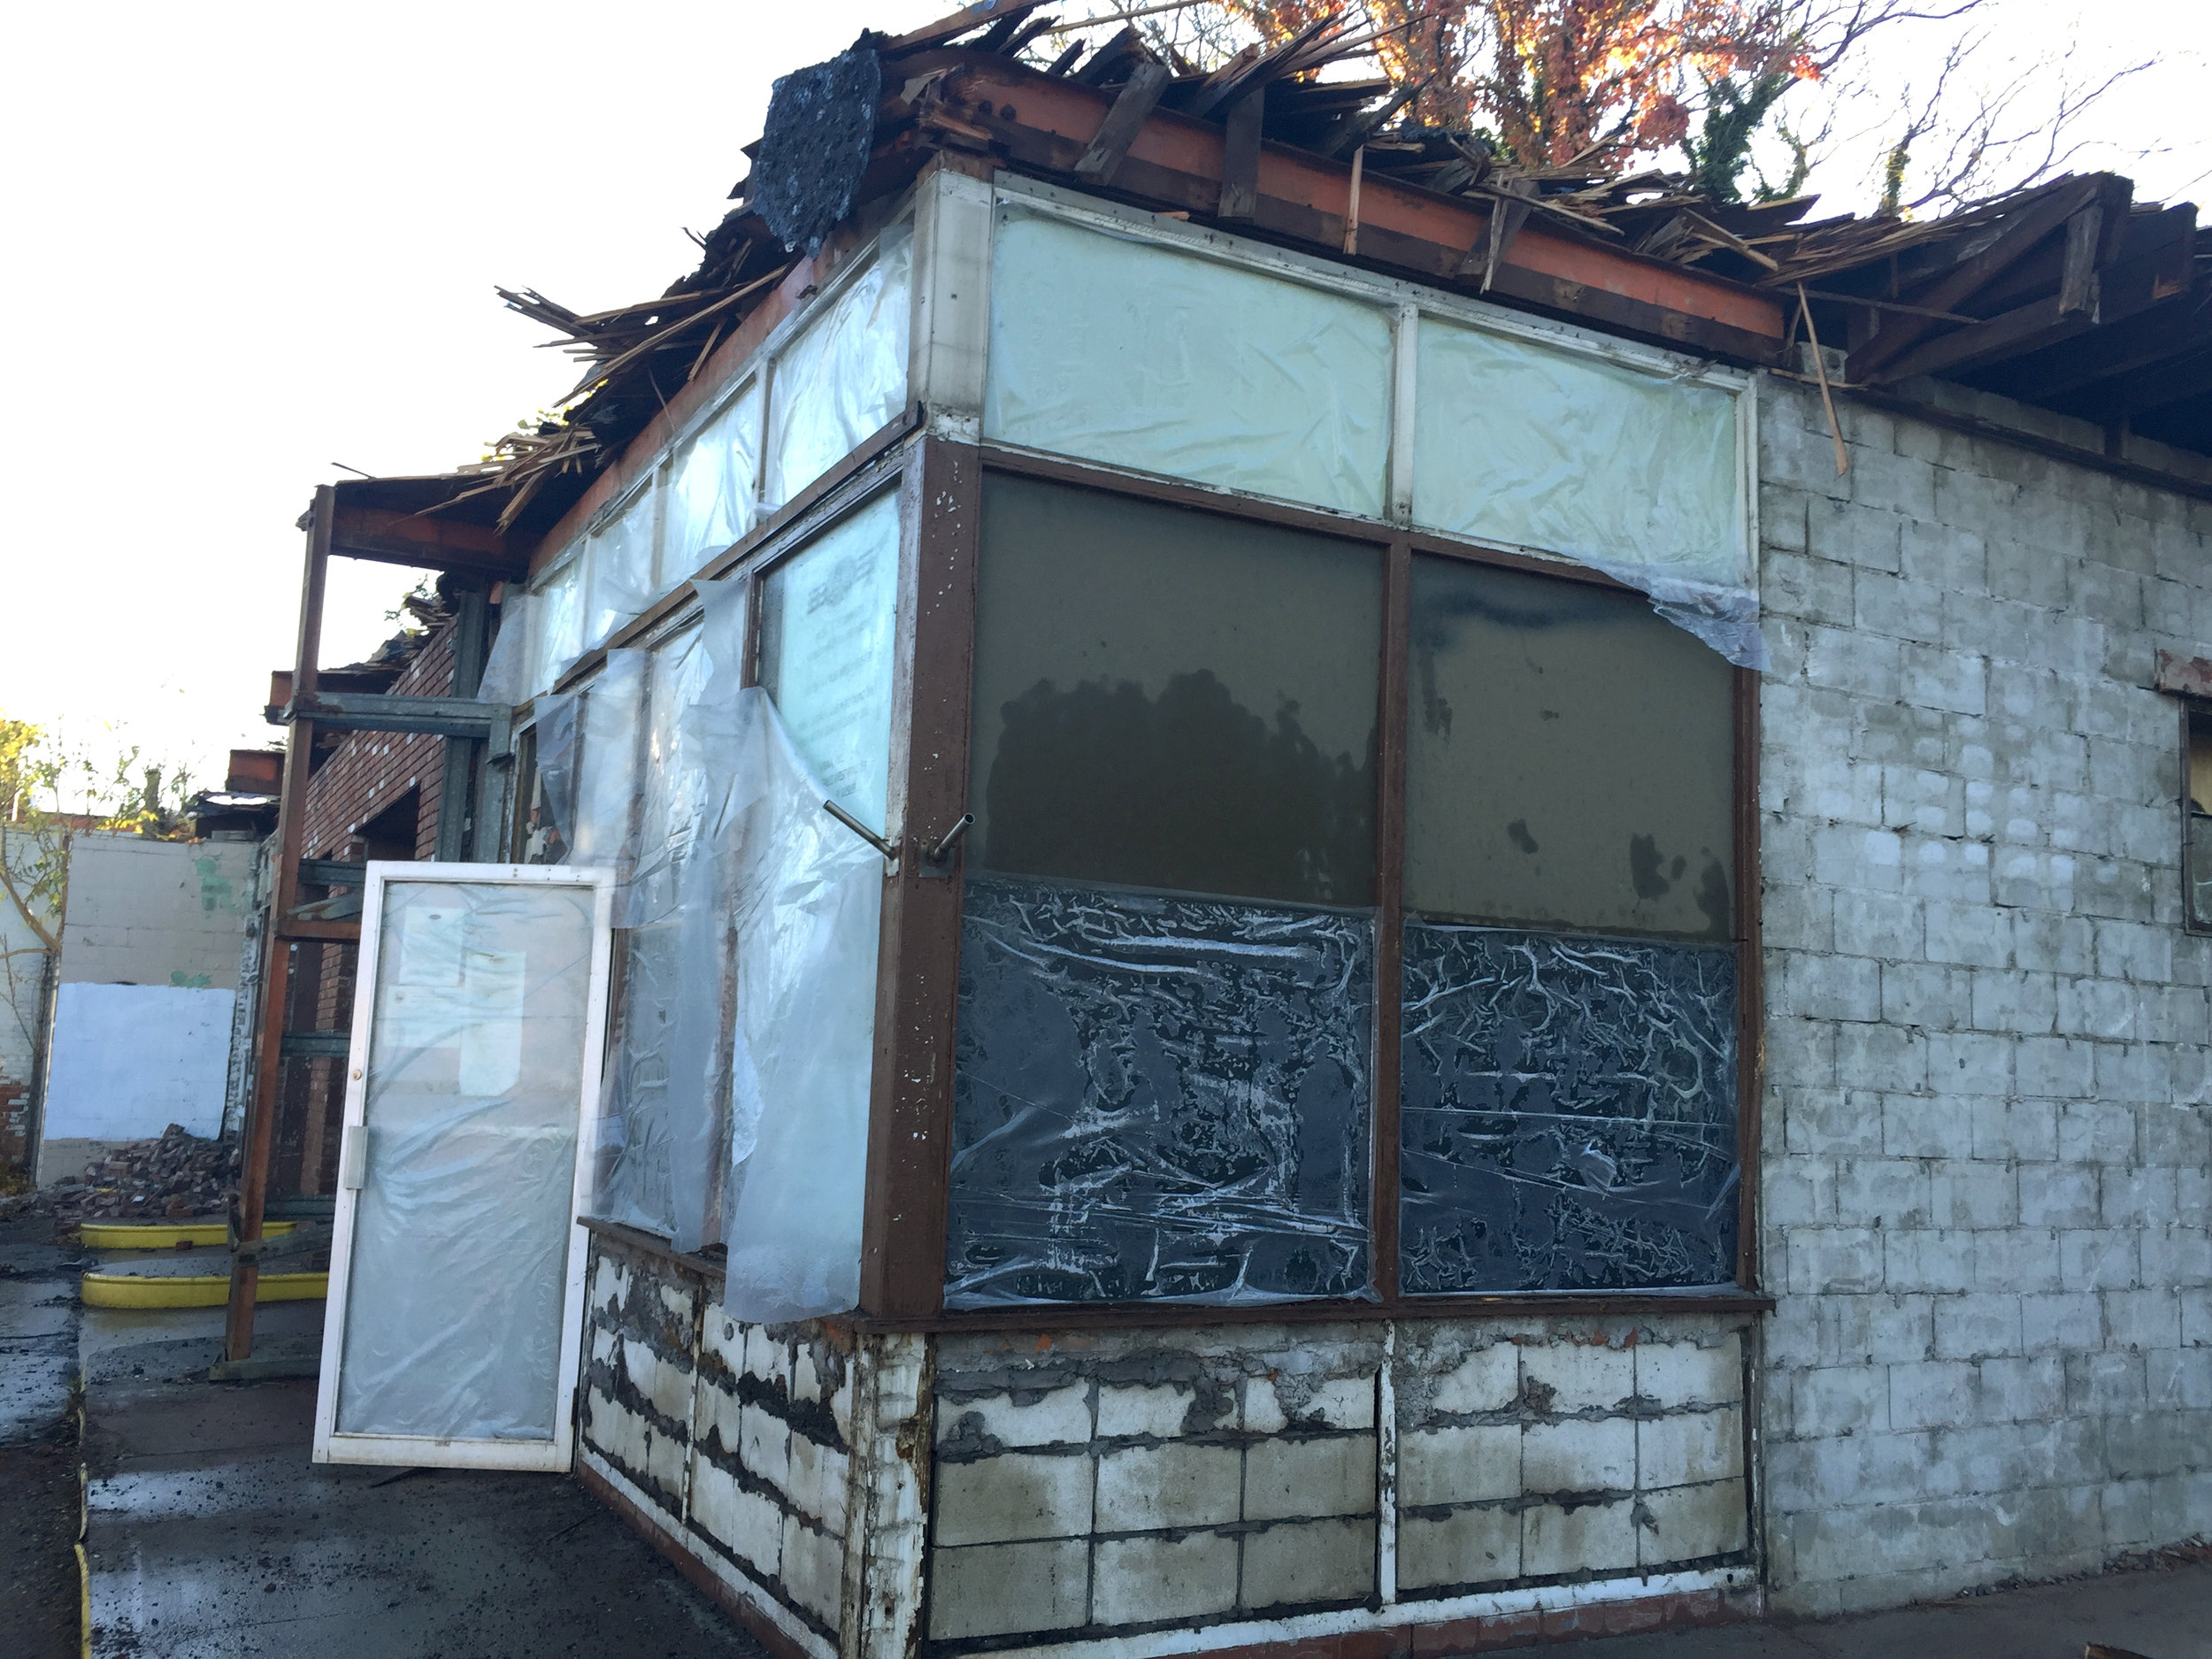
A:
[1401,557,1739,1294]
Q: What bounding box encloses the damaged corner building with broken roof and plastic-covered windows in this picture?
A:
[230,4,2212,1659]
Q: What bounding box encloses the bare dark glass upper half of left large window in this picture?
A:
[969,476,1383,905]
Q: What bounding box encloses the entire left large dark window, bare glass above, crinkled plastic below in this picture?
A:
[947,476,1383,1308]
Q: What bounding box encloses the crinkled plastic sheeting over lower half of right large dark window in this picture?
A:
[1398,918,1739,1294]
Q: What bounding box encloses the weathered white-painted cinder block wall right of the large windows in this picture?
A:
[1759,379,2212,1613]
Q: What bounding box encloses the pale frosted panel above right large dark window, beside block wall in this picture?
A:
[1414,317,1750,587]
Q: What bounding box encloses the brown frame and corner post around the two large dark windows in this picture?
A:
[854,434,1774,1332]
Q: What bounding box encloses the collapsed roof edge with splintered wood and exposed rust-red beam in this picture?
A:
[440,0,2212,546]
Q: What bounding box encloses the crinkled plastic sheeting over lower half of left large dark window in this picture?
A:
[945,876,1374,1308]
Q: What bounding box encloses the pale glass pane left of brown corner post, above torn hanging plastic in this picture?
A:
[761,495,898,834]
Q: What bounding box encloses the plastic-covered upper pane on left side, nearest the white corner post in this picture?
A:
[764,221,914,509]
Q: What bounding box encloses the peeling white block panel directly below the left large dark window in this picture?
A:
[927,1325,1383,1644]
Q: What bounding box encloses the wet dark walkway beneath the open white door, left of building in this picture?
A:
[82,1265,764,1659]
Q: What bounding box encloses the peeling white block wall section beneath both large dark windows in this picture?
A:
[927,1317,1750,1650]
